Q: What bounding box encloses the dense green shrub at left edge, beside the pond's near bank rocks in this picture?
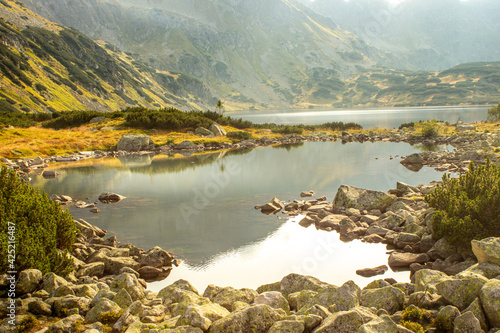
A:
[0,167,76,275]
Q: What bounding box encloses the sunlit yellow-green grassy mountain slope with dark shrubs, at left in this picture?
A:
[0,0,211,111]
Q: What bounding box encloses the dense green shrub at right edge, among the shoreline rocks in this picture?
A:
[425,160,500,247]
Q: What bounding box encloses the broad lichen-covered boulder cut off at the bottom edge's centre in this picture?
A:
[209,304,283,333]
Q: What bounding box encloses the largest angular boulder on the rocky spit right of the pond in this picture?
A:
[333,185,397,211]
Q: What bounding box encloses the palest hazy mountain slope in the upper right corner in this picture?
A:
[299,0,500,70]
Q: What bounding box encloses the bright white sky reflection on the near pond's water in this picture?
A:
[148,217,409,292]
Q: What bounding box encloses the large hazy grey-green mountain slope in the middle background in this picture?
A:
[18,0,394,107]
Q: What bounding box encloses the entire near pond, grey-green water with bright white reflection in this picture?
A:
[33,142,452,291]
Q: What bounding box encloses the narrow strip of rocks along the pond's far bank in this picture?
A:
[0,120,500,178]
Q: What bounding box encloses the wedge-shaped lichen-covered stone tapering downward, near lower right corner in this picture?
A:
[436,273,488,310]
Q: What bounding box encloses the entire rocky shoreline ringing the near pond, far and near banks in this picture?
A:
[0,123,500,333]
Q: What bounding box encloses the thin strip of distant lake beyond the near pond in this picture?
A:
[231,106,491,128]
